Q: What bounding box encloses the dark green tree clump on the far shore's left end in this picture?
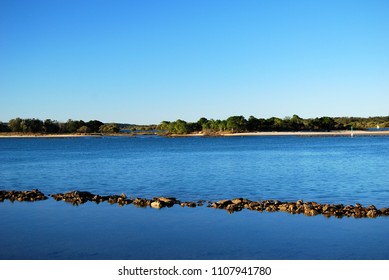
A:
[0,118,120,134]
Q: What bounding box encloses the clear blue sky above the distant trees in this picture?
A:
[0,0,389,124]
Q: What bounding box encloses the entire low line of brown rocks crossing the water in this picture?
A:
[0,189,389,218]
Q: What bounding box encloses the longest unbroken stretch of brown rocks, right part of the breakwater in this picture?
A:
[210,198,389,218]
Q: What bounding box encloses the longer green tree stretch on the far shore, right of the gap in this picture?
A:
[158,115,389,134]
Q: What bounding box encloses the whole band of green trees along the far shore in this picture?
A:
[0,115,389,135]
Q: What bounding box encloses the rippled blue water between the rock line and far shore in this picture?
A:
[0,137,389,207]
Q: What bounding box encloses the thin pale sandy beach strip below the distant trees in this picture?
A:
[0,130,389,138]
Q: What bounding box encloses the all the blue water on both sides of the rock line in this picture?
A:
[0,136,389,259]
